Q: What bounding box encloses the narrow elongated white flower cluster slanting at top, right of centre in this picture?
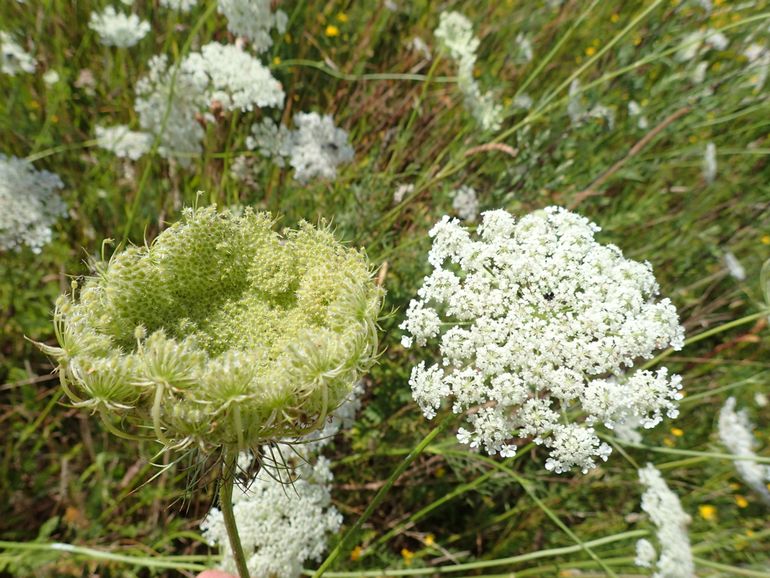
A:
[434,12,503,130]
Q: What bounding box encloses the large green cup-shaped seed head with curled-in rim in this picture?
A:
[41,207,383,450]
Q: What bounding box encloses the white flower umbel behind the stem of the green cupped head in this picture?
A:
[201,446,342,578]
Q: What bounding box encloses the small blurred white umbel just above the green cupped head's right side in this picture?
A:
[289,112,355,182]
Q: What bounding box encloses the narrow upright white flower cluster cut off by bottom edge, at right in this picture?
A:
[636,464,695,578]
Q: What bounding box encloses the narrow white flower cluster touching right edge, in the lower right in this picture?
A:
[719,397,770,504]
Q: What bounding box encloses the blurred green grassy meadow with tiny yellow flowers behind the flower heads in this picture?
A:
[0,0,770,577]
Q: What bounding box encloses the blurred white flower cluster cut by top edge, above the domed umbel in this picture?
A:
[217,0,289,52]
